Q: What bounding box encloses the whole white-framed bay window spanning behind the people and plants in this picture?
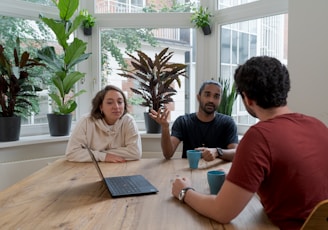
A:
[0,0,288,135]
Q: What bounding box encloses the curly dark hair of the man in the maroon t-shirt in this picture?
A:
[234,56,290,109]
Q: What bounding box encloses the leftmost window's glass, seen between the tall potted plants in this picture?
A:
[0,0,66,136]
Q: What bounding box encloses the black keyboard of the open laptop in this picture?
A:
[108,176,143,194]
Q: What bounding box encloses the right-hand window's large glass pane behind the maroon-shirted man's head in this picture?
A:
[220,14,288,125]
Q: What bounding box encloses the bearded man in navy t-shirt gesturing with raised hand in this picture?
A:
[150,80,238,161]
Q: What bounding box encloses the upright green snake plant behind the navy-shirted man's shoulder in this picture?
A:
[217,78,238,116]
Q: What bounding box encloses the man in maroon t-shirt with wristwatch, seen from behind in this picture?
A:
[172,56,328,230]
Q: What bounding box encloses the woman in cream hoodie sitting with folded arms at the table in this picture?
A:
[66,85,142,163]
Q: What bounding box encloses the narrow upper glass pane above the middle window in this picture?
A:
[95,0,199,14]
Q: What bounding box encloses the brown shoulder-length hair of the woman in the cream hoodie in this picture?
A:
[91,85,128,119]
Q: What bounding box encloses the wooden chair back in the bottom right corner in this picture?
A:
[301,199,328,230]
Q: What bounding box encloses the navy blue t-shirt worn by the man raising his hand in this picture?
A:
[171,112,238,158]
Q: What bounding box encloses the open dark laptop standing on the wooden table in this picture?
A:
[83,146,158,198]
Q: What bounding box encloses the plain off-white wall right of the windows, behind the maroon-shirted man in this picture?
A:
[288,0,328,125]
